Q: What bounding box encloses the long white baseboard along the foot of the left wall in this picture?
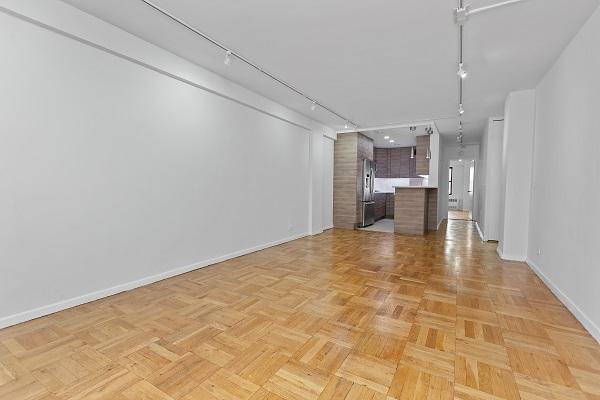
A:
[0,233,308,329]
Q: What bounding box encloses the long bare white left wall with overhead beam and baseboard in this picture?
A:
[0,0,331,327]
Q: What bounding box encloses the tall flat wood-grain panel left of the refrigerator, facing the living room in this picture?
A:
[333,133,358,229]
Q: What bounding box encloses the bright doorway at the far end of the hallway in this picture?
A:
[448,159,475,221]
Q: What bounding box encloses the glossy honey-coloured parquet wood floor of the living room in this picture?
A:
[0,221,600,400]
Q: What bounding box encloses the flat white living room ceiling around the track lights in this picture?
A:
[64,0,598,141]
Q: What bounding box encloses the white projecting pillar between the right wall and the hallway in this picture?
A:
[498,90,535,261]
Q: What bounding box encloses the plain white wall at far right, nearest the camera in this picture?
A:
[527,9,600,341]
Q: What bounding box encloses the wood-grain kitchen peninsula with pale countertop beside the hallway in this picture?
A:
[394,186,438,235]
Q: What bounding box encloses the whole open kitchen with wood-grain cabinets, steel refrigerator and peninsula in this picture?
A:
[334,124,439,235]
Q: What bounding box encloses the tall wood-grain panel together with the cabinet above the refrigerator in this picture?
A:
[333,132,373,229]
